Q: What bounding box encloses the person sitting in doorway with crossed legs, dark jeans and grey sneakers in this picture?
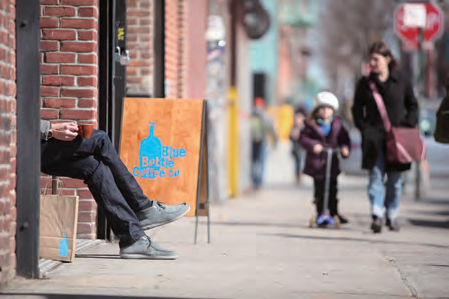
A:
[40,120,190,259]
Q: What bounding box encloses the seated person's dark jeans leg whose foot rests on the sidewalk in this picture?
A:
[41,140,145,247]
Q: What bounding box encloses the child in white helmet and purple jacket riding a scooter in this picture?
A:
[299,91,351,225]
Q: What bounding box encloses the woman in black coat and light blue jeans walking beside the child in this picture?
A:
[352,42,418,233]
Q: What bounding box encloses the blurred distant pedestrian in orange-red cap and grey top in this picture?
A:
[251,98,278,190]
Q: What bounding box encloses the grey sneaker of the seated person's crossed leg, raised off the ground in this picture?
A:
[137,201,190,230]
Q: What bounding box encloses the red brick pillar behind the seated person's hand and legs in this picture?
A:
[40,0,98,239]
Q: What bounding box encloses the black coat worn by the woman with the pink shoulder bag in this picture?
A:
[352,70,418,171]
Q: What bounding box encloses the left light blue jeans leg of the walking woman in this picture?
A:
[368,150,385,218]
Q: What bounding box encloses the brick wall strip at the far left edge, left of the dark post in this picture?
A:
[0,1,17,285]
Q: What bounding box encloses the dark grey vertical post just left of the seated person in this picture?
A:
[16,0,41,278]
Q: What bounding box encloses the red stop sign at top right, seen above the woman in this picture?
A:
[394,2,444,50]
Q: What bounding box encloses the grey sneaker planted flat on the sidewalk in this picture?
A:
[120,236,178,260]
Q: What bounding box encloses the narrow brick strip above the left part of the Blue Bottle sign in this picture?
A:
[126,0,153,94]
